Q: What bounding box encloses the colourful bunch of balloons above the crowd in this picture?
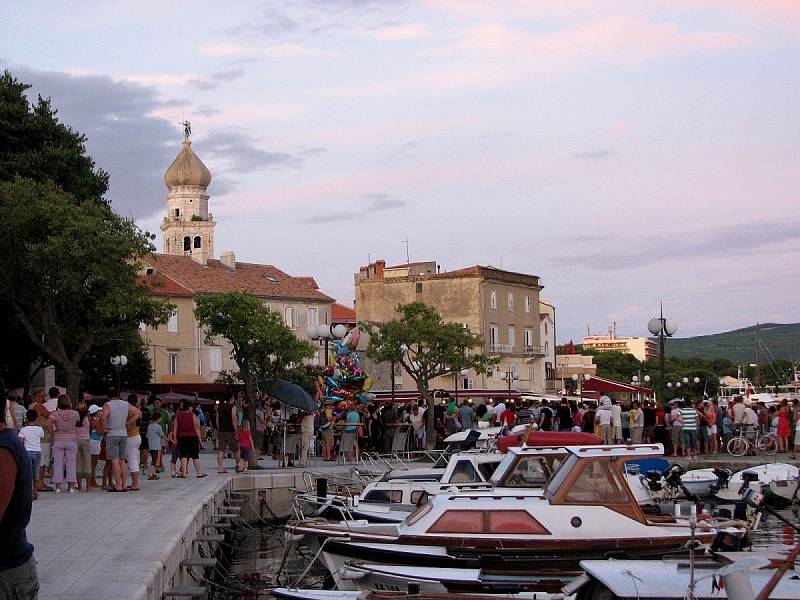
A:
[317,327,375,411]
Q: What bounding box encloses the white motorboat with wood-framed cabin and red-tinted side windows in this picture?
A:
[287,444,716,589]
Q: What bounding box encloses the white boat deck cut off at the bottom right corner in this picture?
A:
[563,552,800,600]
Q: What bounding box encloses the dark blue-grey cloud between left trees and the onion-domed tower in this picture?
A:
[3,65,180,217]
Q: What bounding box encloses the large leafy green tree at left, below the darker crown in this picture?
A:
[0,179,171,398]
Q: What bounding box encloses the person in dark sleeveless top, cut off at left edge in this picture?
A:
[0,390,39,600]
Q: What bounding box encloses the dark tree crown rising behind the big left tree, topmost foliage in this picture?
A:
[0,71,108,203]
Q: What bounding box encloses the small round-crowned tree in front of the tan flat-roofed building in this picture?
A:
[362,302,498,448]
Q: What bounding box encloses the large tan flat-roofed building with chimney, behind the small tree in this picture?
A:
[355,260,555,393]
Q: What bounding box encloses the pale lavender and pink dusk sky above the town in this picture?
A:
[0,0,800,342]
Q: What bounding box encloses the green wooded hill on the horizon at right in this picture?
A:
[666,323,800,364]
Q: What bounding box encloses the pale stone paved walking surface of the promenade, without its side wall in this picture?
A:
[27,453,350,600]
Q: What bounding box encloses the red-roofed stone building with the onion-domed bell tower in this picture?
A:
[139,139,333,383]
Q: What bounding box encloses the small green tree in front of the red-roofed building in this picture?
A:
[194,292,314,410]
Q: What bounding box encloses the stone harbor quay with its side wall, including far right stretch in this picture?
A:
[28,453,797,600]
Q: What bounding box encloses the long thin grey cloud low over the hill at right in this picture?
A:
[550,220,800,271]
